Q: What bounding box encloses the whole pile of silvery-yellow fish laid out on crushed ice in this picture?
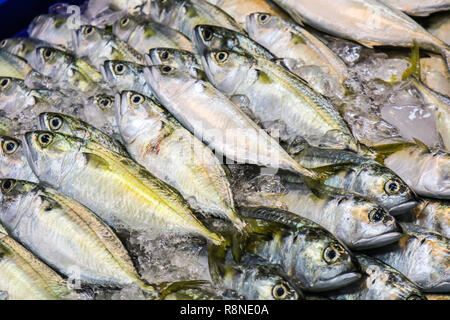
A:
[0,0,450,300]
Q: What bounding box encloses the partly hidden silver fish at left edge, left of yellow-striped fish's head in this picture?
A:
[0,136,38,182]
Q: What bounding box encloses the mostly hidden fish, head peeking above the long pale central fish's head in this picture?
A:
[145,48,206,78]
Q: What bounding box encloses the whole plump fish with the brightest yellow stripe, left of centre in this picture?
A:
[25,131,223,243]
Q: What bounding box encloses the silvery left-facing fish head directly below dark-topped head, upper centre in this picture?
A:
[202,50,257,94]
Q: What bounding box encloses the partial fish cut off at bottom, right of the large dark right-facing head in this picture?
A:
[356,253,426,300]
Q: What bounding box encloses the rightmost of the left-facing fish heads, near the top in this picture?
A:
[246,12,283,41]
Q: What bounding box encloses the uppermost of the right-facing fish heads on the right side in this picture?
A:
[354,164,417,215]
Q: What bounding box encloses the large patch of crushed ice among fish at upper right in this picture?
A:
[328,39,446,146]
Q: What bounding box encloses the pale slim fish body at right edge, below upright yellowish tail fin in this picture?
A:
[411,78,450,152]
